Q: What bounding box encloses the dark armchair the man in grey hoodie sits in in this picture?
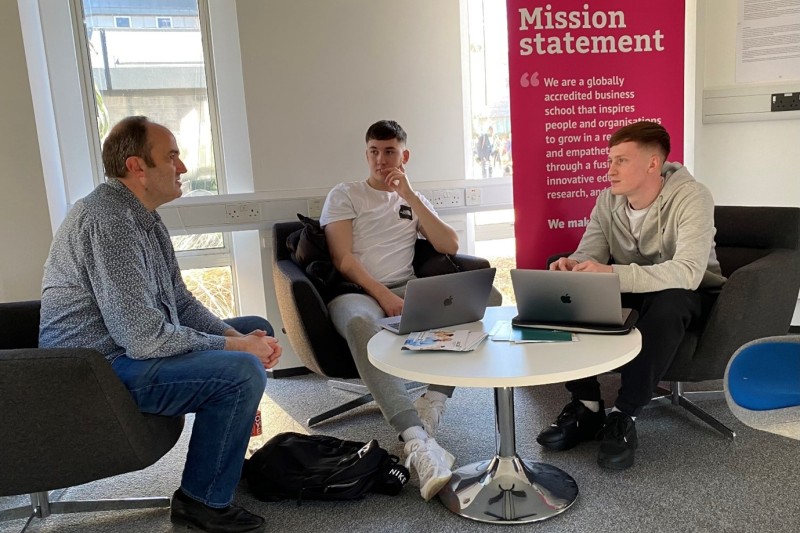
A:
[548,206,800,439]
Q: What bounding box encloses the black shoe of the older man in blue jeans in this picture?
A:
[169,489,264,533]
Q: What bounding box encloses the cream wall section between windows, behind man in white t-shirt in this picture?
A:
[237,0,465,196]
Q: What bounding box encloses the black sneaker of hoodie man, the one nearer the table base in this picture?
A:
[536,400,606,451]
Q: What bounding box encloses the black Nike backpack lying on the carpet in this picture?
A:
[242,432,410,505]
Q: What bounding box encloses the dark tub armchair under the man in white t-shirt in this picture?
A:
[272,218,500,427]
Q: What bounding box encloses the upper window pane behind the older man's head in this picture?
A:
[80,0,221,195]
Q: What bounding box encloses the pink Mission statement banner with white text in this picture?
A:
[507,0,685,268]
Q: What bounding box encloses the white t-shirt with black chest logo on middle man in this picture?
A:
[319,181,436,285]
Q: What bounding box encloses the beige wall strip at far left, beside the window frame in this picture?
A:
[0,2,52,302]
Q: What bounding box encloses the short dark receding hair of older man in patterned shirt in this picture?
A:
[103,116,155,178]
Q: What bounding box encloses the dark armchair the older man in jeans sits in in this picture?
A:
[0,301,183,526]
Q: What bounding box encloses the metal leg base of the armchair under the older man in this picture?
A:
[0,492,170,533]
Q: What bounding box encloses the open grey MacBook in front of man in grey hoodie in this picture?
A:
[511,269,638,333]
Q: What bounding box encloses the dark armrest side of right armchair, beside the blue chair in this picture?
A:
[694,249,800,375]
